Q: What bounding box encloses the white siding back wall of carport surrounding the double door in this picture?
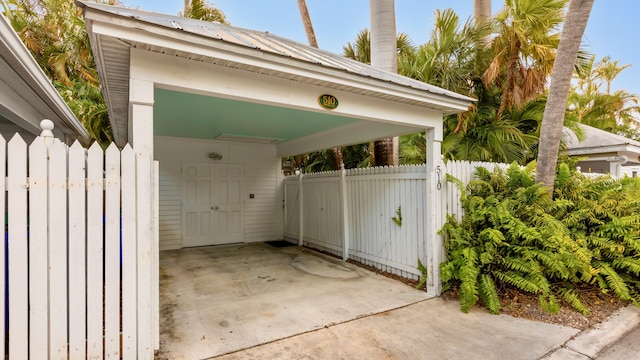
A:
[154,136,283,250]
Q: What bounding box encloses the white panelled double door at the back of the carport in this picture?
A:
[182,163,244,247]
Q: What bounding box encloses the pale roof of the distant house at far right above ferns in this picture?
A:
[563,124,640,165]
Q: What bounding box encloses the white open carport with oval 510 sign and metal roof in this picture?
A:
[76,1,473,354]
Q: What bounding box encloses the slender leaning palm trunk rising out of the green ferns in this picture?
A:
[536,0,594,193]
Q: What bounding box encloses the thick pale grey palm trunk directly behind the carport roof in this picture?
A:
[369,0,398,166]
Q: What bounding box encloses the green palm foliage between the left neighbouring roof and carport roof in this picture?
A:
[1,0,115,146]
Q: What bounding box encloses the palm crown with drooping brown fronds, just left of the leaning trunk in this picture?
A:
[483,0,564,117]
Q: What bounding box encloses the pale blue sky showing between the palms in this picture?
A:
[122,0,640,95]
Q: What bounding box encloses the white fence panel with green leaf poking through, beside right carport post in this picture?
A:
[346,166,426,278]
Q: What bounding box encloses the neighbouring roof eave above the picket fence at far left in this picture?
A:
[0,15,90,143]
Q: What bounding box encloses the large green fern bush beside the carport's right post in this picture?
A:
[440,163,640,314]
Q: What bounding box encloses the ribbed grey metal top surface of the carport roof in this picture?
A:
[77,1,476,102]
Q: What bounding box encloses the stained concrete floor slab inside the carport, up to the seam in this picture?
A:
[157,243,428,360]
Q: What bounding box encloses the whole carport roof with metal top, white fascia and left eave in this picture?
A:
[76,0,475,148]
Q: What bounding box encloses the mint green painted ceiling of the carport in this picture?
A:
[153,89,358,141]
